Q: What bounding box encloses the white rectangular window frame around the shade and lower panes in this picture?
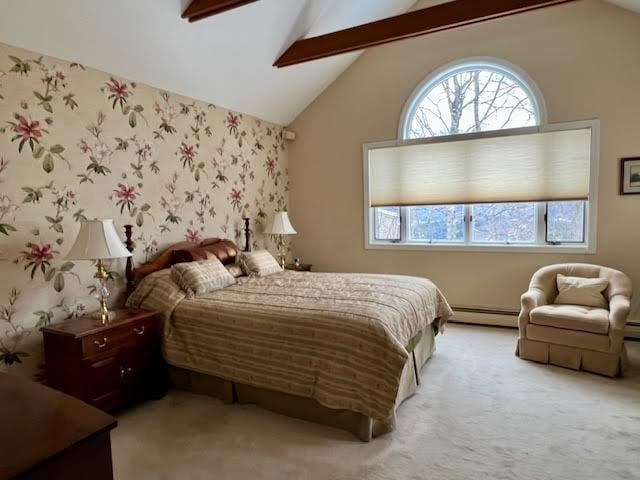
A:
[362,120,600,254]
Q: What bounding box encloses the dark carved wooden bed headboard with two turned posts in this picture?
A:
[124,218,251,294]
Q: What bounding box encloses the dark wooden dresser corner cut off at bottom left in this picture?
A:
[0,373,117,480]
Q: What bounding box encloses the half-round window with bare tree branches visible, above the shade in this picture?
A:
[400,61,542,139]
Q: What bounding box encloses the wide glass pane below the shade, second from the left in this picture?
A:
[408,205,464,243]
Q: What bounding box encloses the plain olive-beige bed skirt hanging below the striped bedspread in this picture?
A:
[169,322,437,442]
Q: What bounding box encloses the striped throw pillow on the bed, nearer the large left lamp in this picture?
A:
[171,258,236,297]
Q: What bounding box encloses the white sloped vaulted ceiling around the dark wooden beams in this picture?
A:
[0,0,640,125]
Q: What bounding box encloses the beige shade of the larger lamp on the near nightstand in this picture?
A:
[67,219,131,260]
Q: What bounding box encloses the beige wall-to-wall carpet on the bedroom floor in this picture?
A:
[113,325,640,480]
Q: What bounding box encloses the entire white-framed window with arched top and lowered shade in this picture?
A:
[365,60,598,251]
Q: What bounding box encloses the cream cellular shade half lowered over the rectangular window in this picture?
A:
[369,128,591,207]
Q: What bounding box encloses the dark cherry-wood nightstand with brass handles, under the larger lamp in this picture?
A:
[42,309,167,411]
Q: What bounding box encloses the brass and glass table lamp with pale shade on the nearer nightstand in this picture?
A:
[66,219,131,325]
